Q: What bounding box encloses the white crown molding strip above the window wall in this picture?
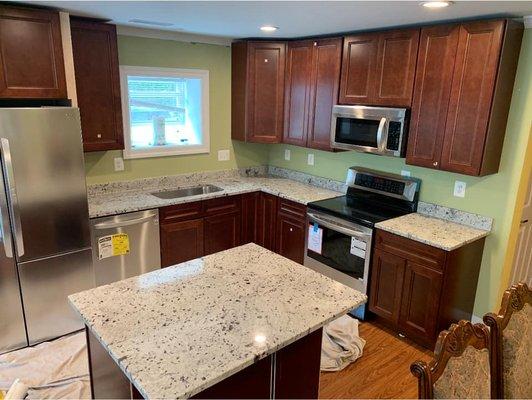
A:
[116,25,232,46]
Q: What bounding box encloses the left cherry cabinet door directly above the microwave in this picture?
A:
[339,33,380,104]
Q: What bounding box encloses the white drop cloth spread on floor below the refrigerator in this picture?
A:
[0,332,90,399]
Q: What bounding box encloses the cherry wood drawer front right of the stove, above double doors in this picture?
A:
[375,229,447,271]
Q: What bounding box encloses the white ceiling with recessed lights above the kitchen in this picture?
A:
[23,1,532,38]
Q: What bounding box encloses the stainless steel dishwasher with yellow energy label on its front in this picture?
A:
[91,210,161,286]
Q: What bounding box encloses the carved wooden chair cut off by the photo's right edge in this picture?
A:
[484,283,532,399]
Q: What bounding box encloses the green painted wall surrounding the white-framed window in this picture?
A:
[85,36,269,184]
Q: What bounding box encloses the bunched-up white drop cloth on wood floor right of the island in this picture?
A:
[321,315,366,371]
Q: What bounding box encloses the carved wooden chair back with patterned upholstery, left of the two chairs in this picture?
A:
[410,320,491,399]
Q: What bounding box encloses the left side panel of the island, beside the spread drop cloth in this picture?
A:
[85,327,142,399]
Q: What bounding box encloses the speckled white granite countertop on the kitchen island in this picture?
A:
[69,244,367,398]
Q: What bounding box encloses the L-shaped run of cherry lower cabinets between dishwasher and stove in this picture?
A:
[159,192,307,267]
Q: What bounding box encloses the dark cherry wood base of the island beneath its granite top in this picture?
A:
[85,328,322,399]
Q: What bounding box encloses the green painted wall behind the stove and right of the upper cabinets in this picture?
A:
[269,29,532,316]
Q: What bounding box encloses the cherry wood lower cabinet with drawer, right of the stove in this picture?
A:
[369,229,484,349]
